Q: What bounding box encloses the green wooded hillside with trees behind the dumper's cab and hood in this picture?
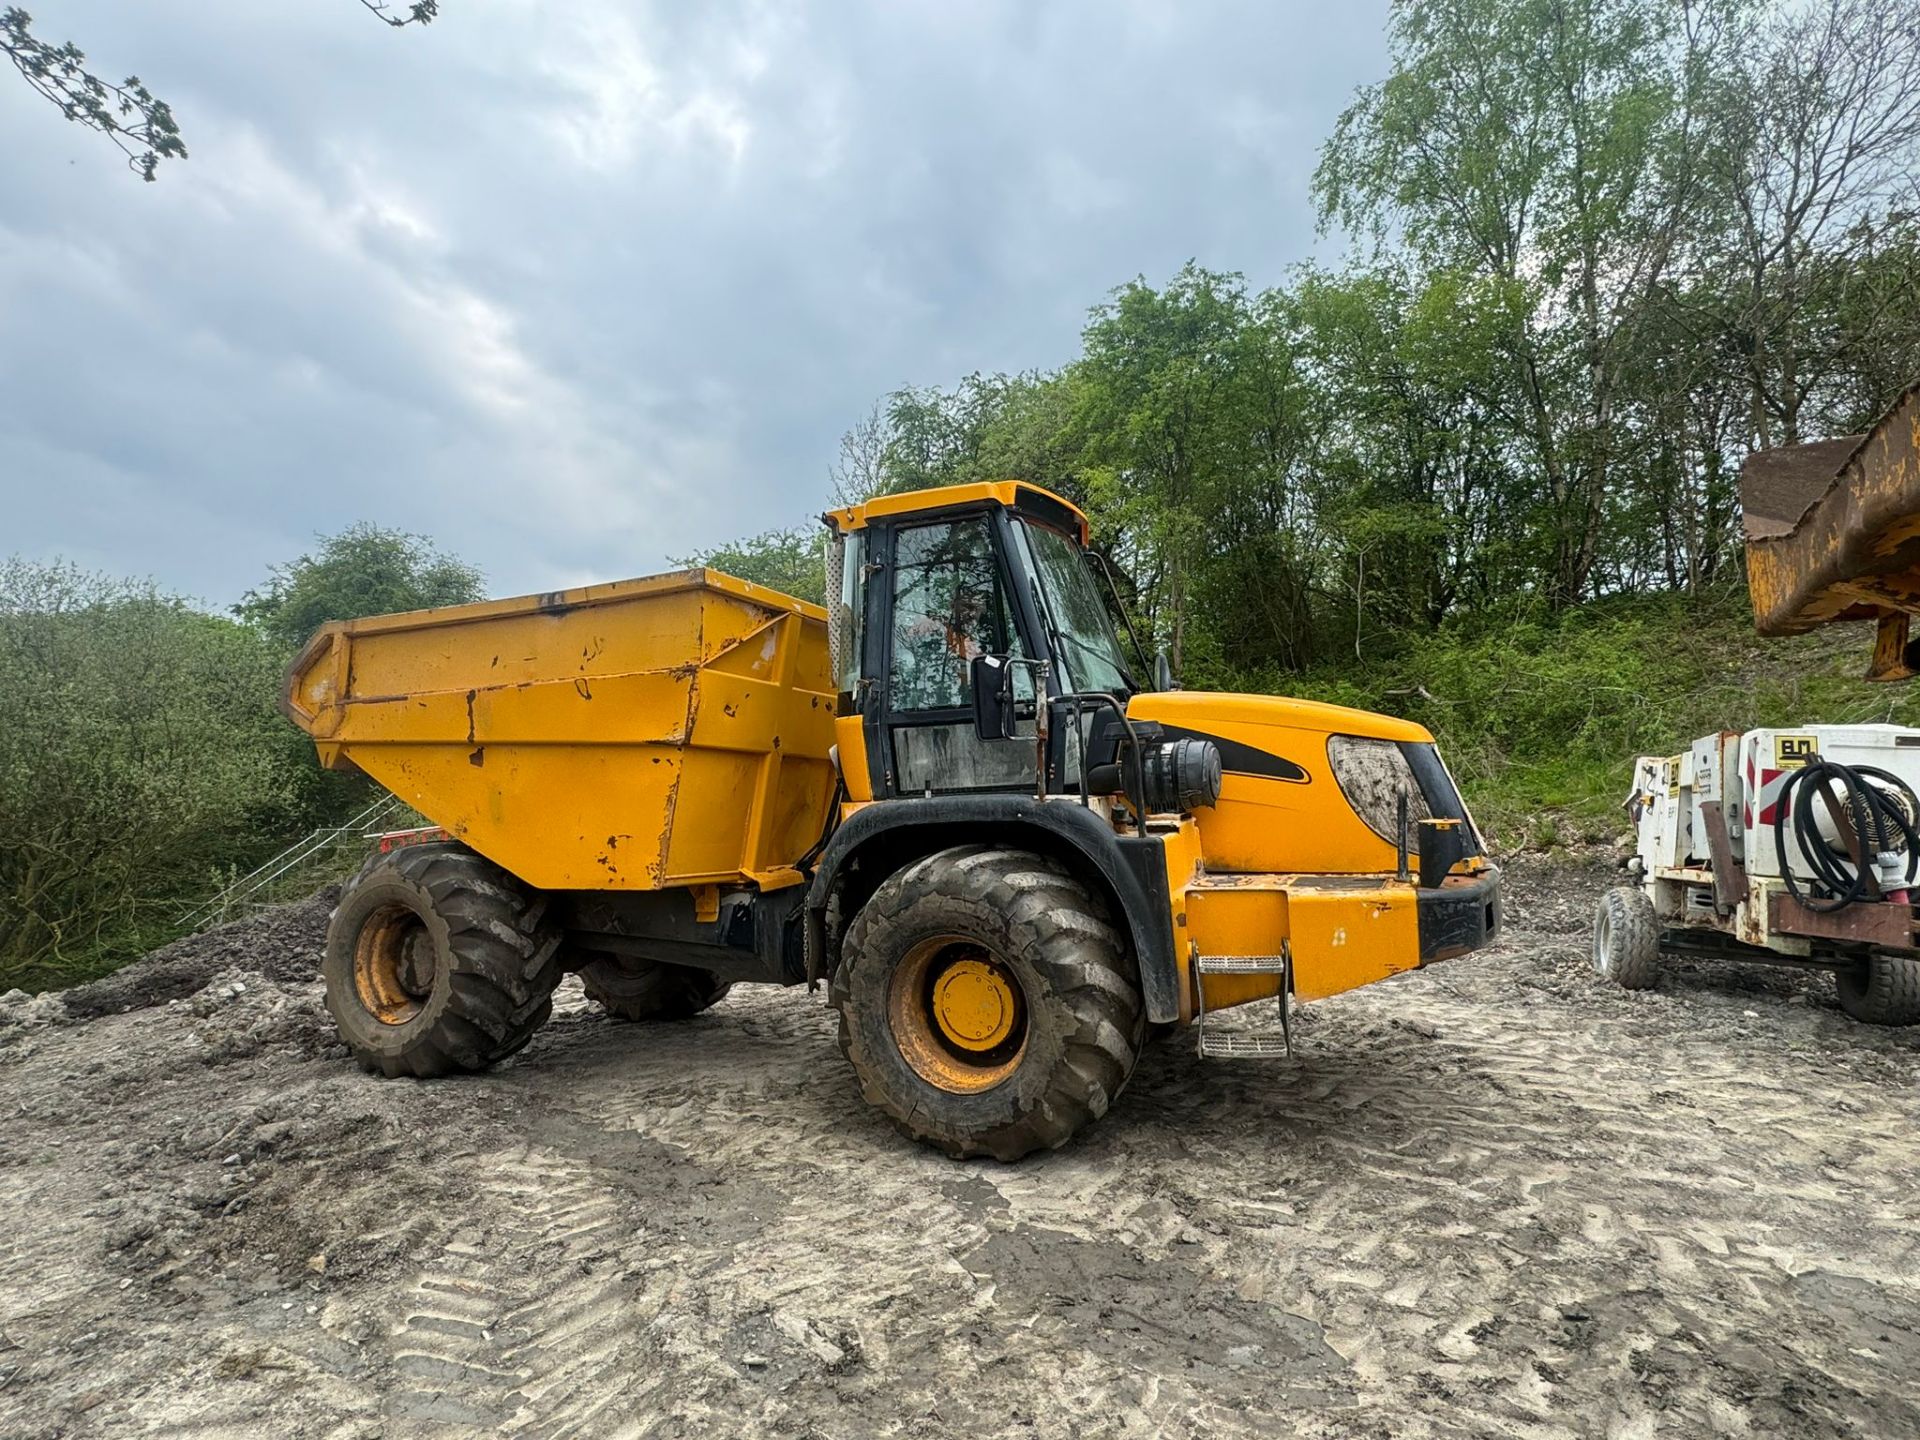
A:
[695,0,1920,843]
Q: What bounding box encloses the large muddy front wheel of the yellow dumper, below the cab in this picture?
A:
[833,845,1146,1160]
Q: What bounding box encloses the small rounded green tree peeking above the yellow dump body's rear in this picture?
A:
[234,522,486,655]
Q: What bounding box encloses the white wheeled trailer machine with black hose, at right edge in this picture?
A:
[1594,726,1920,1025]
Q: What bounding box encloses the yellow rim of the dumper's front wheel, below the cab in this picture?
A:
[887,935,1027,1094]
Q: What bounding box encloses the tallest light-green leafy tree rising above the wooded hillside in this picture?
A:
[1315,0,1741,603]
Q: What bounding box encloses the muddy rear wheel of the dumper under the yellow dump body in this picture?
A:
[321,845,561,1077]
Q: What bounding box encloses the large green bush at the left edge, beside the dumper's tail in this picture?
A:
[0,561,313,989]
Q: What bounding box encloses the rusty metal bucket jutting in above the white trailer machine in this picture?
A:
[1740,384,1920,641]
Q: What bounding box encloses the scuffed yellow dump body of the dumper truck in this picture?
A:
[284,570,833,891]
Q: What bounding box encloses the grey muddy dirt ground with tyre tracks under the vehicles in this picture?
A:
[0,864,1920,1440]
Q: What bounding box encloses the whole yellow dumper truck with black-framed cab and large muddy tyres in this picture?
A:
[286,482,1500,1160]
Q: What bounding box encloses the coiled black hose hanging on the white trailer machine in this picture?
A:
[1774,760,1920,914]
